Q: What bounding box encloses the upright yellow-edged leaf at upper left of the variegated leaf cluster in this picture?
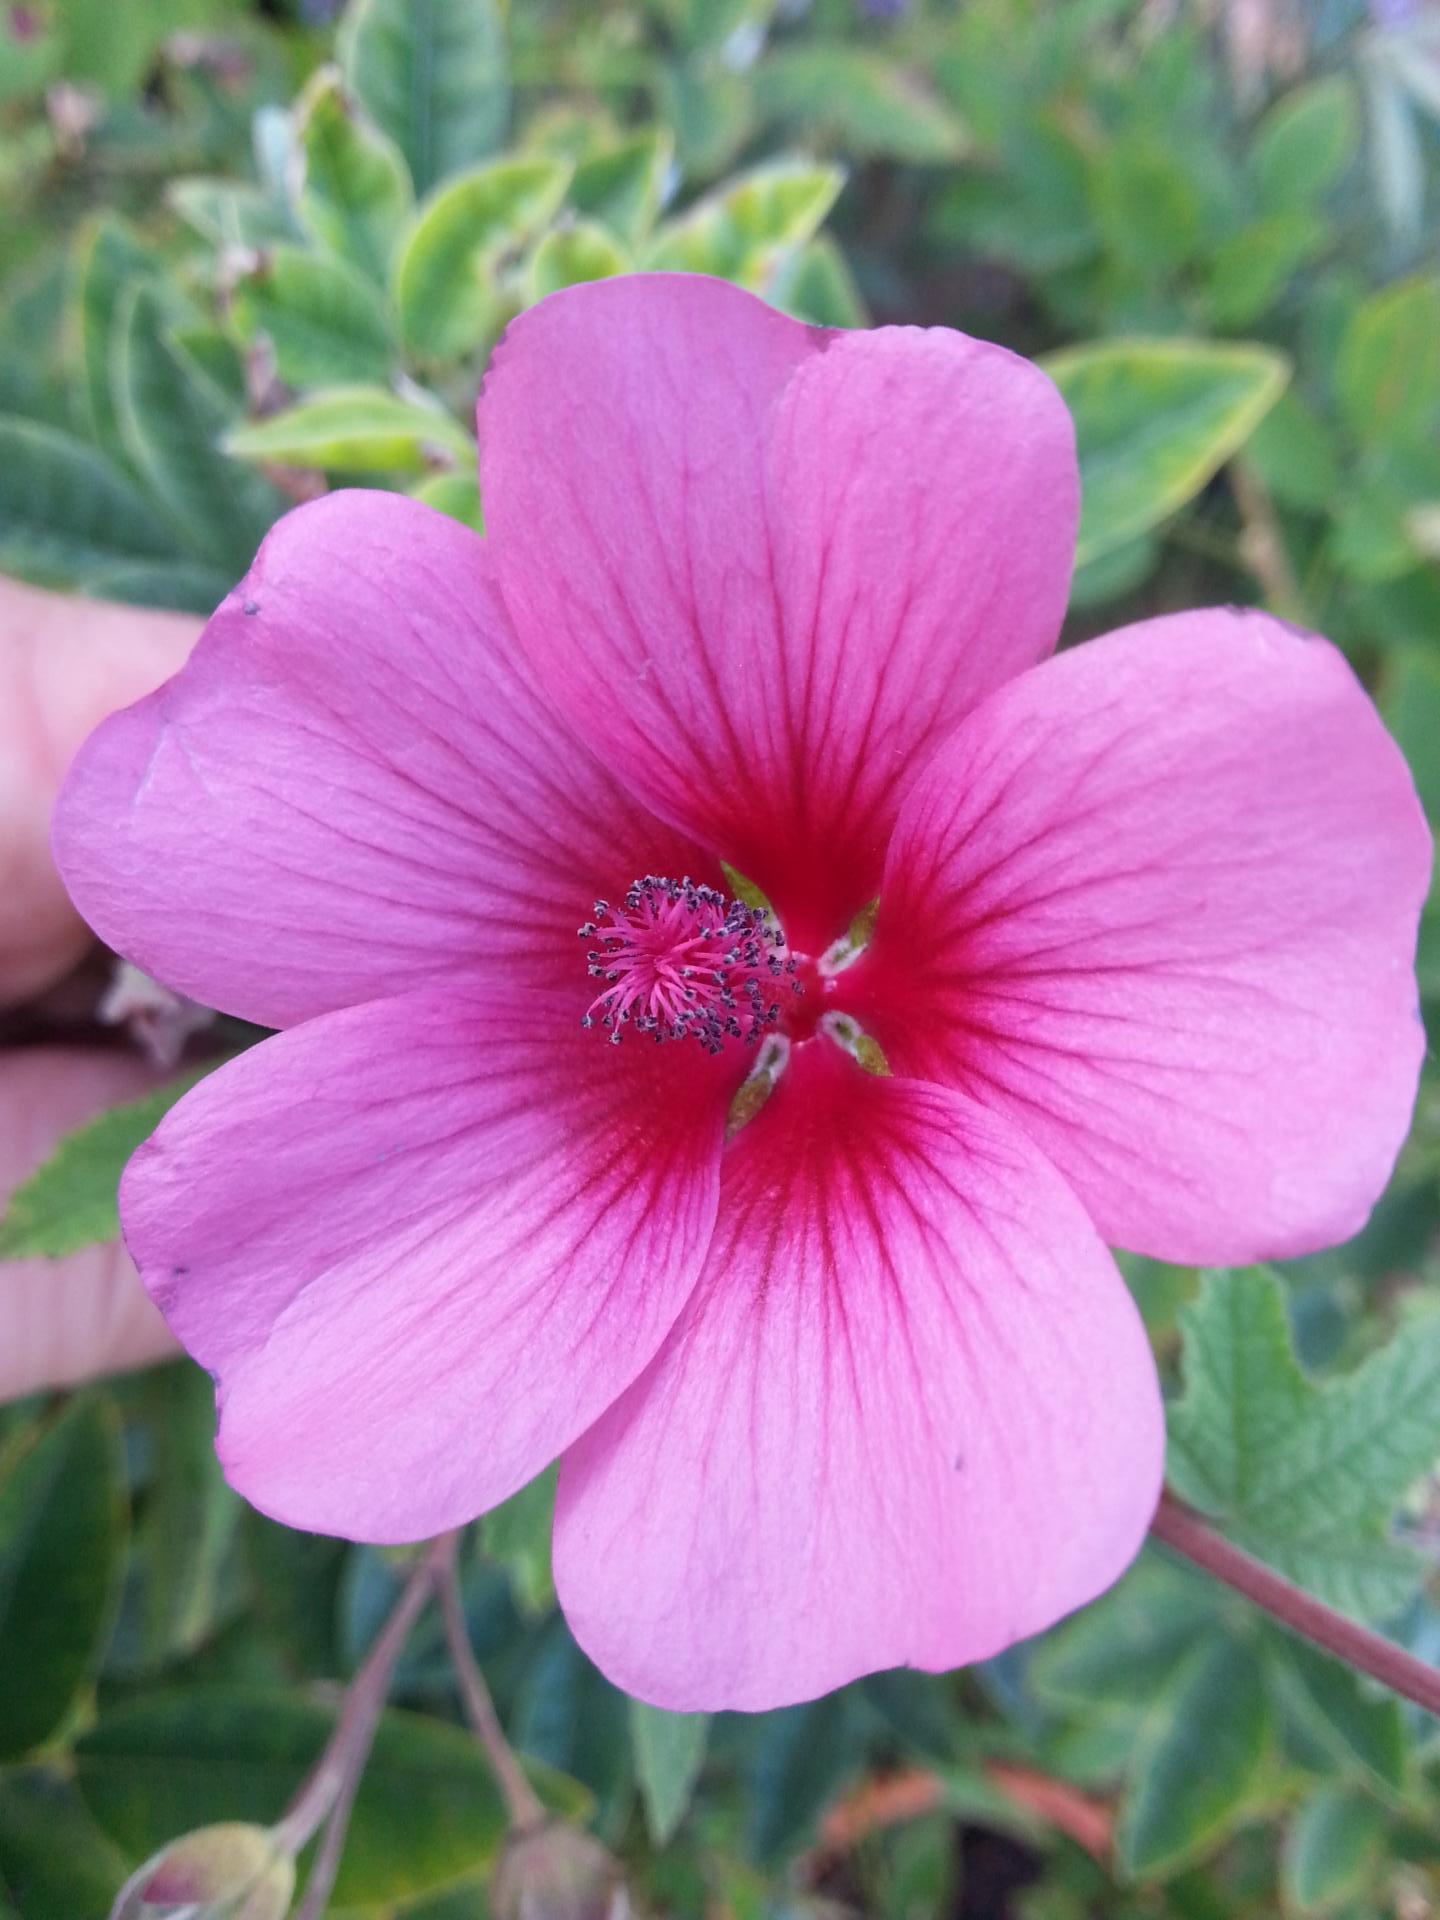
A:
[296,69,415,286]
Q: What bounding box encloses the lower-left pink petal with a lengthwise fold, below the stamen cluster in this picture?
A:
[121,983,735,1540]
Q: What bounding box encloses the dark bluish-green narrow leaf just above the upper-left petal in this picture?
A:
[111,288,286,578]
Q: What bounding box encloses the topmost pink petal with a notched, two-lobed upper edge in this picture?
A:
[480,275,1077,948]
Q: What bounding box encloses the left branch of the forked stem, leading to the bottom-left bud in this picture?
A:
[275,1534,459,1920]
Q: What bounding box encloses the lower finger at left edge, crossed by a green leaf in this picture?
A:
[0,1046,175,1402]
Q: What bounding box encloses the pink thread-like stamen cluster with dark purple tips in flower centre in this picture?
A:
[580,874,801,1054]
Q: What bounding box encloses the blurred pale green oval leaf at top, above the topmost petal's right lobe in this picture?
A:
[755,42,970,167]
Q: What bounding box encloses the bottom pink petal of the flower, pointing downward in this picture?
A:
[555,1044,1164,1709]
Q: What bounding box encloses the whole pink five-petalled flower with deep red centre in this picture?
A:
[58,276,1430,1707]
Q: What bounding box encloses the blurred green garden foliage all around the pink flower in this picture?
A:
[0,0,1440,1920]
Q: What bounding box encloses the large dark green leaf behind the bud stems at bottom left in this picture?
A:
[75,1688,586,1908]
